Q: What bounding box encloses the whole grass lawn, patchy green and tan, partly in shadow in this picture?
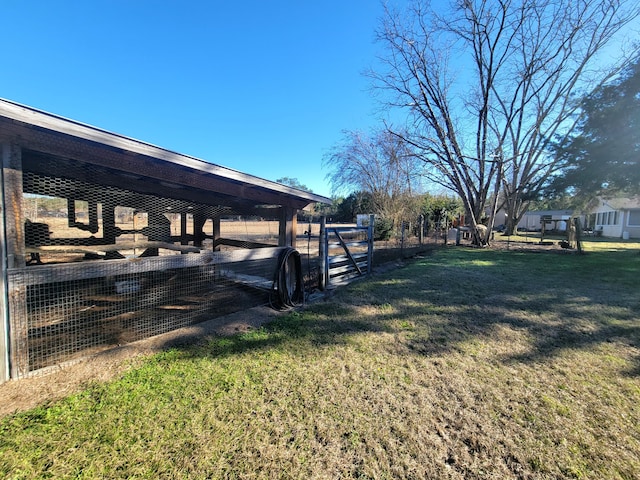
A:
[0,247,640,479]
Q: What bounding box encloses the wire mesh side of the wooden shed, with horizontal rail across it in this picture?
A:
[8,154,282,376]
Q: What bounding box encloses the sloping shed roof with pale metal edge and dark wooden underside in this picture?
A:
[0,99,331,211]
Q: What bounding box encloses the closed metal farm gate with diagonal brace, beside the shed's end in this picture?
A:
[320,215,374,289]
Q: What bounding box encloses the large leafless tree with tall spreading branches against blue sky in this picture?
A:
[372,0,639,243]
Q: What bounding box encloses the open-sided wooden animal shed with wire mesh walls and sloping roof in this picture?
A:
[0,100,330,381]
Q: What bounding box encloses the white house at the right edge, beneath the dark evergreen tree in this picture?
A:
[591,197,640,239]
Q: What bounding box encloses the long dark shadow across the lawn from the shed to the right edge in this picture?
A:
[158,248,640,376]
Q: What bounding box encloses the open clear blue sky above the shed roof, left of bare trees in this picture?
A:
[0,0,400,196]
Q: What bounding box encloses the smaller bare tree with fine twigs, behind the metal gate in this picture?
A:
[323,129,421,228]
